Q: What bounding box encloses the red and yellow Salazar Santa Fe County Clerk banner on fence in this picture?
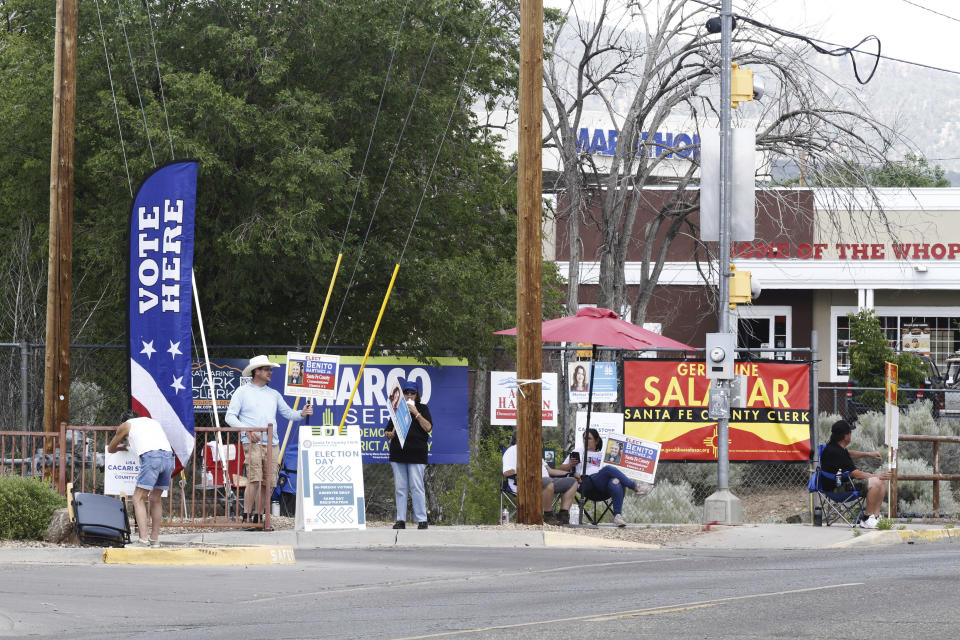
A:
[623,360,813,462]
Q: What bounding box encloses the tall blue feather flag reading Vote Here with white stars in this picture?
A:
[129,161,197,466]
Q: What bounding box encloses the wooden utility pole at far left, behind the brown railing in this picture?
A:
[43,0,78,432]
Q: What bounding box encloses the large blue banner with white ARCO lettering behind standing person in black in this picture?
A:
[270,355,470,468]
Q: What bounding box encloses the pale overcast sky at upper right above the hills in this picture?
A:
[544,0,960,71]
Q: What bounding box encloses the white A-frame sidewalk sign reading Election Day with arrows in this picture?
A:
[296,425,367,531]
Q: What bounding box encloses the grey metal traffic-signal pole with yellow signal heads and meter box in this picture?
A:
[701,0,760,524]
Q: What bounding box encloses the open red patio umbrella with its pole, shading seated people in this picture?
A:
[494,307,697,517]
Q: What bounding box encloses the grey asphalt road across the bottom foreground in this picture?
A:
[0,543,960,640]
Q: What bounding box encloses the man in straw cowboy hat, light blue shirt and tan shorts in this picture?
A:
[226,356,313,522]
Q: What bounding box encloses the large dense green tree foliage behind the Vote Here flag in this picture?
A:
[0,0,554,357]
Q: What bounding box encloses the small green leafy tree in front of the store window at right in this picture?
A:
[847,309,926,406]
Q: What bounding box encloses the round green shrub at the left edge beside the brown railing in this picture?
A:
[0,476,66,540]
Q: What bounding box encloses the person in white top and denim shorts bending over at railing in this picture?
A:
[107,411,174,547]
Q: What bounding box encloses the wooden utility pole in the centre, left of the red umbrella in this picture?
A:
[517,0,543,524]
